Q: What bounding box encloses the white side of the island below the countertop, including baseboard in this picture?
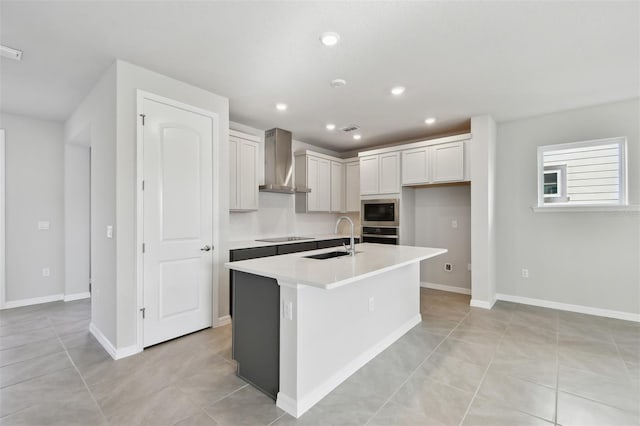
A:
[278,262,421,417]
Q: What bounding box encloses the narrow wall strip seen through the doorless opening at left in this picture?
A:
[64,144,91,299]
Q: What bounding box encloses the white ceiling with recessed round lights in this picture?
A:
[0,0,640,151]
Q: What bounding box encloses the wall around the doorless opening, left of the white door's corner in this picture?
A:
[64,64,117,346]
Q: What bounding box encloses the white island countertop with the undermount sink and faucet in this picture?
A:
[224,243,447,289]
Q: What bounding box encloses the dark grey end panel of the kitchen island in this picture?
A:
[232,271,280,399]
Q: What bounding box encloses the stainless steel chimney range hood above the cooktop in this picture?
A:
[259,128,311,194]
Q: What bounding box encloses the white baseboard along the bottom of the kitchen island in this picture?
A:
[276,314,422,418]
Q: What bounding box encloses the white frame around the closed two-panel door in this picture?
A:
[135,89,220,352]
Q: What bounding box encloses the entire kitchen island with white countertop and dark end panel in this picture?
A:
[225,244,447,417]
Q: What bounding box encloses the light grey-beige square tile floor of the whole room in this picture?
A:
[0,289,640,426]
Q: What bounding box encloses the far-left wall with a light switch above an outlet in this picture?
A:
[0,113,64,303]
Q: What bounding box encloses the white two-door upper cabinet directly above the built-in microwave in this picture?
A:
[360,152,400,195]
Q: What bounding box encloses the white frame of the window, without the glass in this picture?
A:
[535,136,629,210]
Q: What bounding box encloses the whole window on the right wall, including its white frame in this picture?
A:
[538,137,627,207]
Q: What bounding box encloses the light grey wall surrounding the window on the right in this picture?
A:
[496,99,640,314]
